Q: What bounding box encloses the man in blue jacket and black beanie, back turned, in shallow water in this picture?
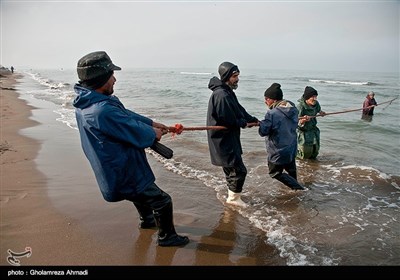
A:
[258,83,304,190]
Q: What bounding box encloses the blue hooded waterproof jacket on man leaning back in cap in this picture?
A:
[73,84,156,202]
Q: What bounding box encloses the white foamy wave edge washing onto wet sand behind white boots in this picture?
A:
[146,149,338,266]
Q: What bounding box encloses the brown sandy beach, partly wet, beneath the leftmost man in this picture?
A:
[0,71,285,274]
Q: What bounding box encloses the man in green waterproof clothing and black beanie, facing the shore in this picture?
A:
[297,86,325,159]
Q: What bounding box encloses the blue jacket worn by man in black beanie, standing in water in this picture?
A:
[258,100,298,165]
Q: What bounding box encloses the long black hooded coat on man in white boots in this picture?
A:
[207,77,258,167]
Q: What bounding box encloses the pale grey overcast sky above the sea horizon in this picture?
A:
[0,0,400,72]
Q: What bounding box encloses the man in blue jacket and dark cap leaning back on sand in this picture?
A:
[73,51,189,246]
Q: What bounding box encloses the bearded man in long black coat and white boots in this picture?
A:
[207,62,258,207]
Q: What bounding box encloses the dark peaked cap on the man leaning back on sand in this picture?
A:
[77,51,121,82]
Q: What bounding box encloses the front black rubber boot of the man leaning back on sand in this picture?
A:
[154,203,189,247]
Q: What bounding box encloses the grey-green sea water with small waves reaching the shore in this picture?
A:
[15,69,400,265]
